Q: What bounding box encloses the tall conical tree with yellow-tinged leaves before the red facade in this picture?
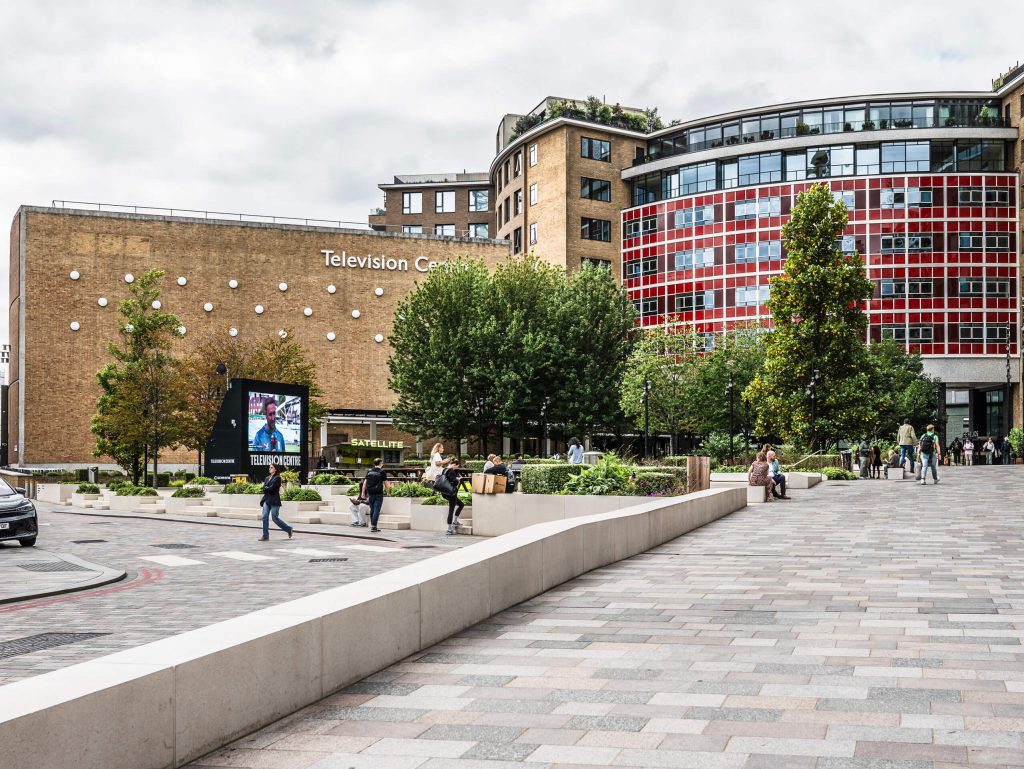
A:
[743,184,874,444]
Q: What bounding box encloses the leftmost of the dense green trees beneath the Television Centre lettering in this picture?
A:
[388,259,497,448]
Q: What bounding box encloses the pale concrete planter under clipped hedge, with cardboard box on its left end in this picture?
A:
[473,494,649,537]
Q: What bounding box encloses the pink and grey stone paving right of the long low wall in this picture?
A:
[193,467,1024,769]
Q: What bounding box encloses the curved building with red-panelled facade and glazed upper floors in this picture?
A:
[621,68,1024,438]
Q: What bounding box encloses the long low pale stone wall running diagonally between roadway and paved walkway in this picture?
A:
[0,488,745,769]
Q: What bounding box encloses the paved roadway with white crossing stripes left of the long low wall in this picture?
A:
[0,504,478,684]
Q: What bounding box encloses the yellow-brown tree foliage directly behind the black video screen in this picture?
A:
[178,329,327,464]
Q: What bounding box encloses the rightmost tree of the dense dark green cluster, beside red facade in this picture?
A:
[545,264,636,437]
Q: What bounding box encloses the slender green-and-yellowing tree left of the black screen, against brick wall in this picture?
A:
[92,269,181,482]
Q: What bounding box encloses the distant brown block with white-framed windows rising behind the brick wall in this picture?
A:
[370,173,495,238]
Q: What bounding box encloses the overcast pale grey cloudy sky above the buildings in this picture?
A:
[0,0,1024,338]
